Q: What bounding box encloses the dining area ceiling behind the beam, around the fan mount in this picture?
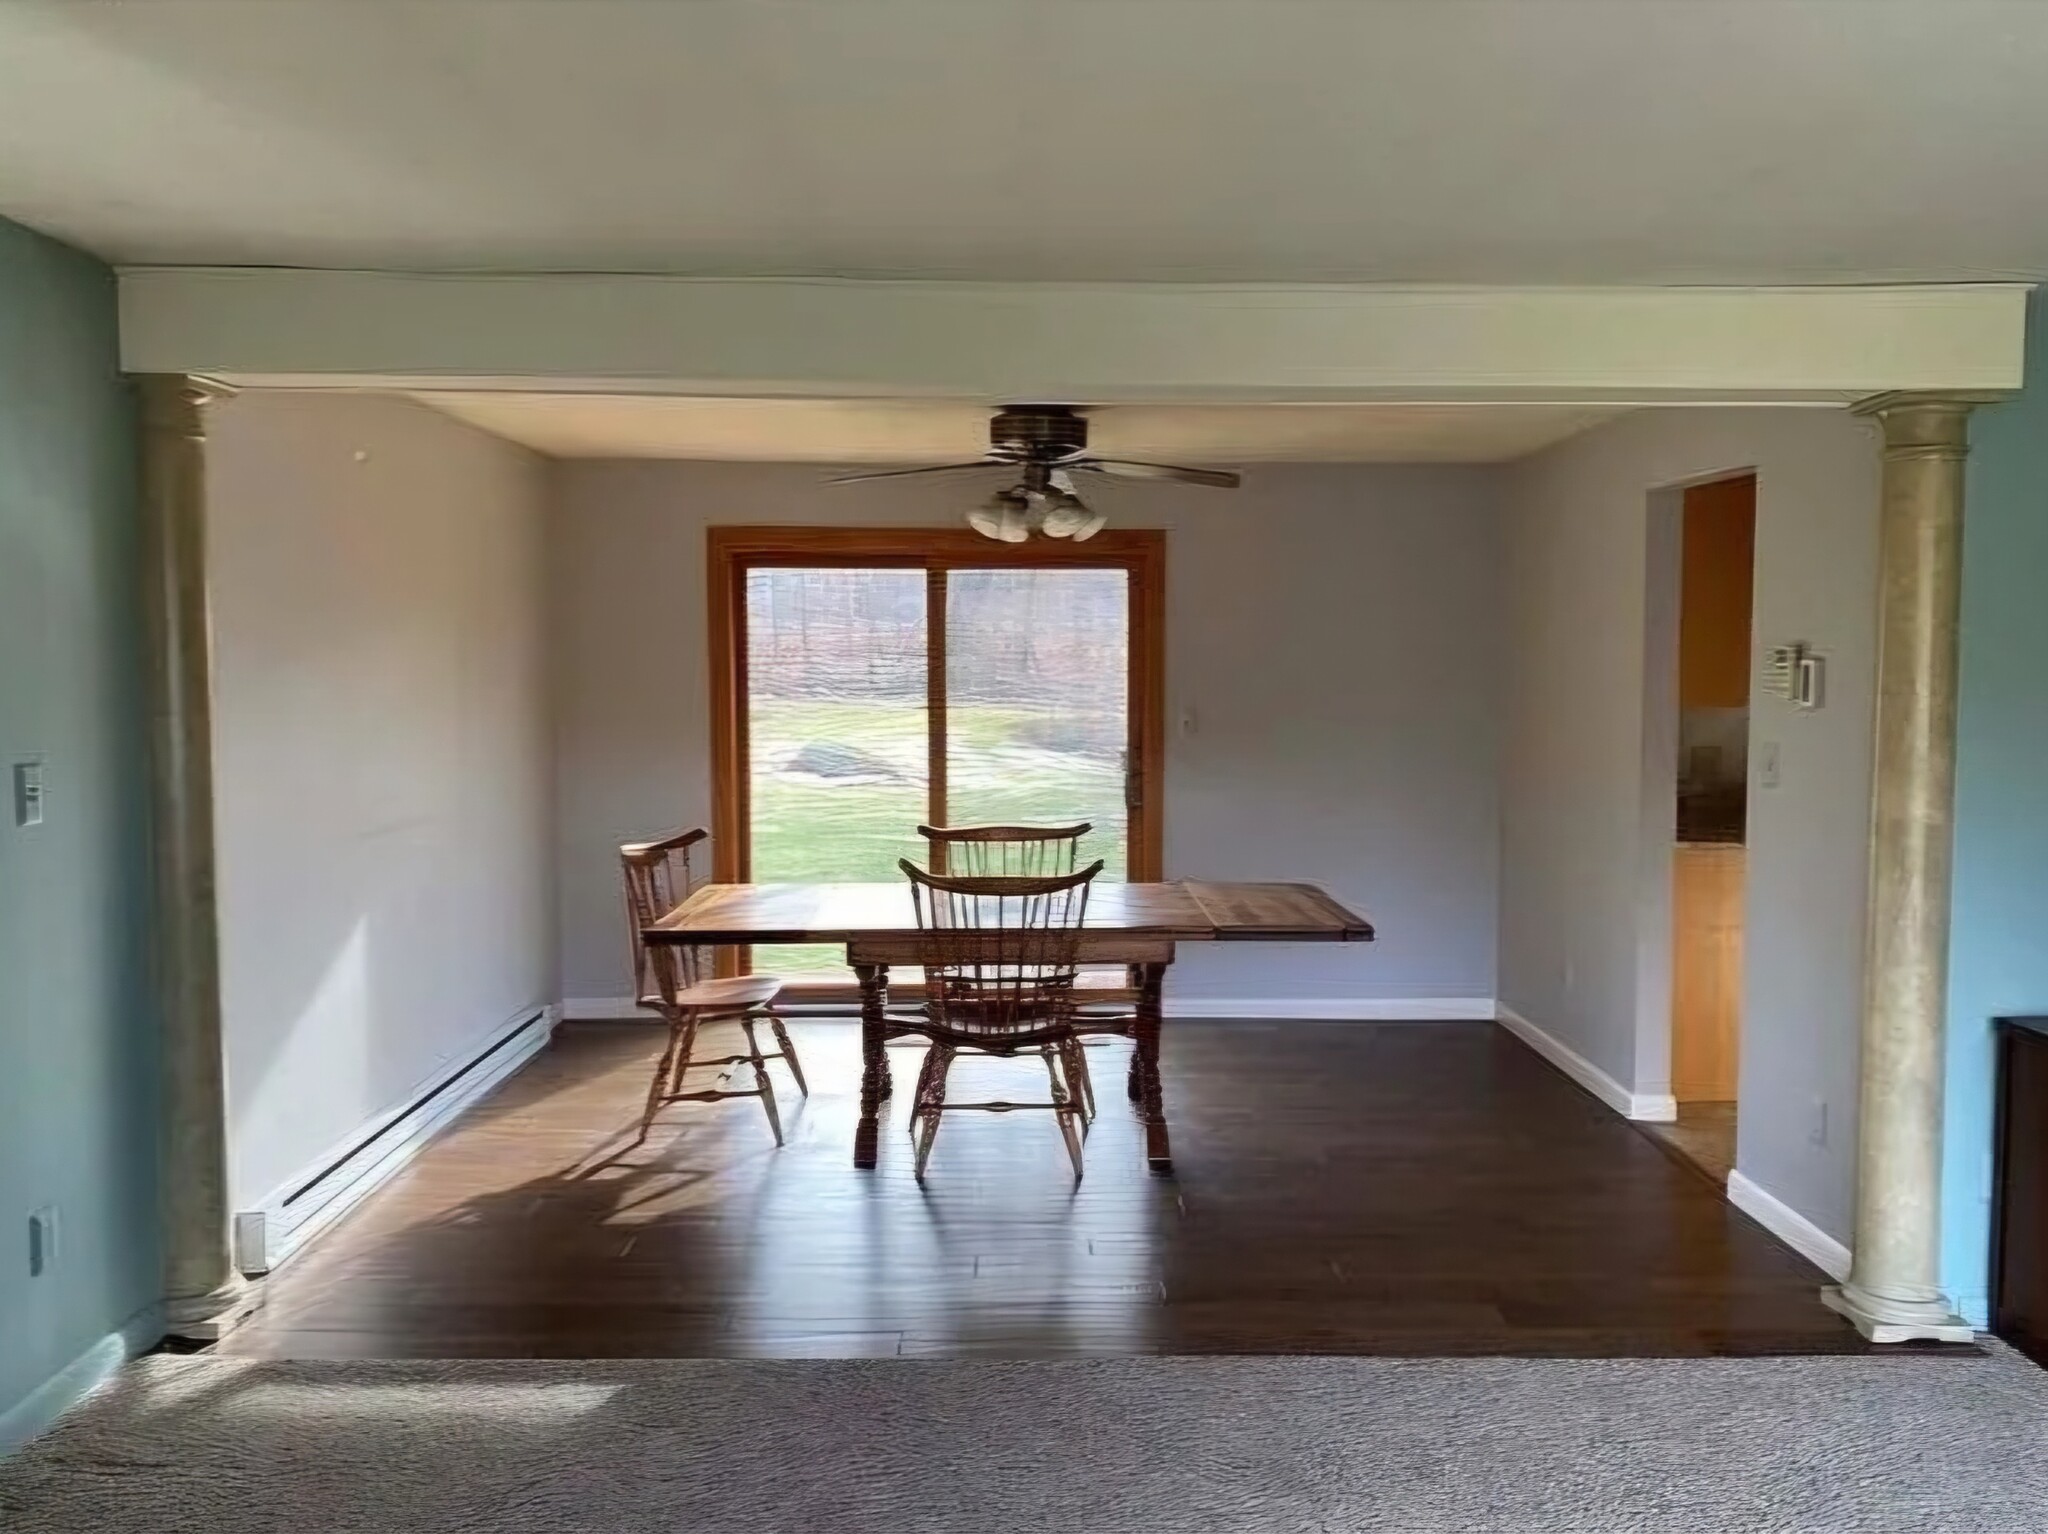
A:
[414,393,1618,465]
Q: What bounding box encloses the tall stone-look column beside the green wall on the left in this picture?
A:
[137,373,248,1341]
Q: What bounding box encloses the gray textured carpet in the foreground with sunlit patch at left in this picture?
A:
[0,1350,2048,1534]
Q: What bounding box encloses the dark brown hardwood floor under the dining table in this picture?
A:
[219,1022,1864,1358]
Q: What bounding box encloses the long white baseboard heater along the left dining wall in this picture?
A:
[233,1006,559,1278]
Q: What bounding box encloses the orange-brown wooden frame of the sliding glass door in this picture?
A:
[705,526,1165,883]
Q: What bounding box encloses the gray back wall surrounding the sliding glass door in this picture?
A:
[549,463,1501,1002]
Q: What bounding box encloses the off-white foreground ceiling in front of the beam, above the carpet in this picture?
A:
[12,0,2048,283]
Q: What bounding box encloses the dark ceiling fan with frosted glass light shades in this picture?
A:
[829,406,1239,543]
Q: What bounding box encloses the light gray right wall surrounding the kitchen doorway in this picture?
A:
[1499,410,1878,1241]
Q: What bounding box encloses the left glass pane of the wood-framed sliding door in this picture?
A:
[748,569,930,975]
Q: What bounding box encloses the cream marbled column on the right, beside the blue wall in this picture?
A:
[1823,393,1978,1341]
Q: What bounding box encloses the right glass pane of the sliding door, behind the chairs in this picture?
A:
[946,569,1130,879]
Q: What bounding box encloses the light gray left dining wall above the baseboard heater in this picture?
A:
[209,393,555,1208]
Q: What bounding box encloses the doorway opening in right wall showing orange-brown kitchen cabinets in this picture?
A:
[1659,475,1757,1184]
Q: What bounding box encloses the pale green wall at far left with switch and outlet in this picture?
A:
[0,221,160,1450]
